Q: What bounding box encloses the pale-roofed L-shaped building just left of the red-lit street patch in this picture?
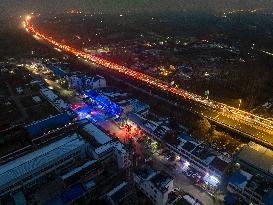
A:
[81,123,131,169]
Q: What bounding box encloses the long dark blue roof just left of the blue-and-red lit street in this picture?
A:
[26,112,73,138]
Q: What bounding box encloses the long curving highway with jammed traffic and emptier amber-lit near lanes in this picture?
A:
[23,16,273,147]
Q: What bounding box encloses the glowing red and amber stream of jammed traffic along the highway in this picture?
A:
[22,16,273,143]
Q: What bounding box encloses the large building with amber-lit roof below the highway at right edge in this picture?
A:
[234,142,273,183]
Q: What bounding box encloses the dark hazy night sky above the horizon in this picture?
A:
[0,0,273,16]
